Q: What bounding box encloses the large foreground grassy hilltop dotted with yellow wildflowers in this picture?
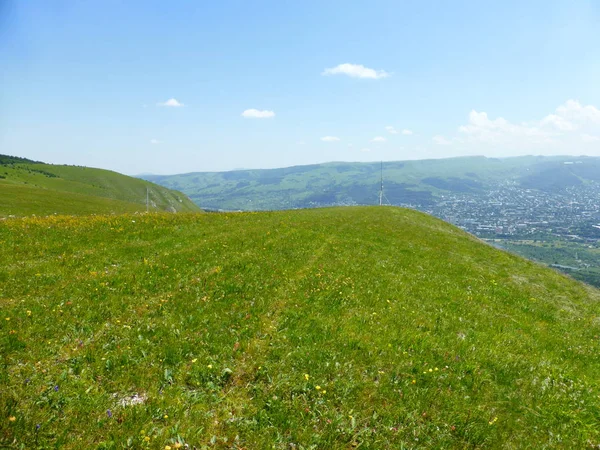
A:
[0,207,600,449]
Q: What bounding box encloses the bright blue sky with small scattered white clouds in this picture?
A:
[0,0,600,174]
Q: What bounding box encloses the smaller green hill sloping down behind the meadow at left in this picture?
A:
[0,155,199,217]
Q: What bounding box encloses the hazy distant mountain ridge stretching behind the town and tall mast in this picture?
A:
[141,156,600,210]
